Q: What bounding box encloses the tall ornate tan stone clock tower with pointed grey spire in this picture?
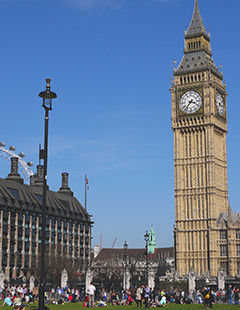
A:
[171,0,229,275]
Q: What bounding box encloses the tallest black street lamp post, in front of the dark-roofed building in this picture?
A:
[39,79,57,310]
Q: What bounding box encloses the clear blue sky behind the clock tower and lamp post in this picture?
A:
[0,0,240,247]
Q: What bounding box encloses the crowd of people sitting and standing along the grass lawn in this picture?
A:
[0,283,239,310]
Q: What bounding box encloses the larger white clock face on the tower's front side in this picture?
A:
[179,90,202,114]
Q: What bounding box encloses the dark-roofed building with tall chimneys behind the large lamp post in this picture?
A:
[0,157,93,280]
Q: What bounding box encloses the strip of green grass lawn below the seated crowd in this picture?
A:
[30,303,240,310]
